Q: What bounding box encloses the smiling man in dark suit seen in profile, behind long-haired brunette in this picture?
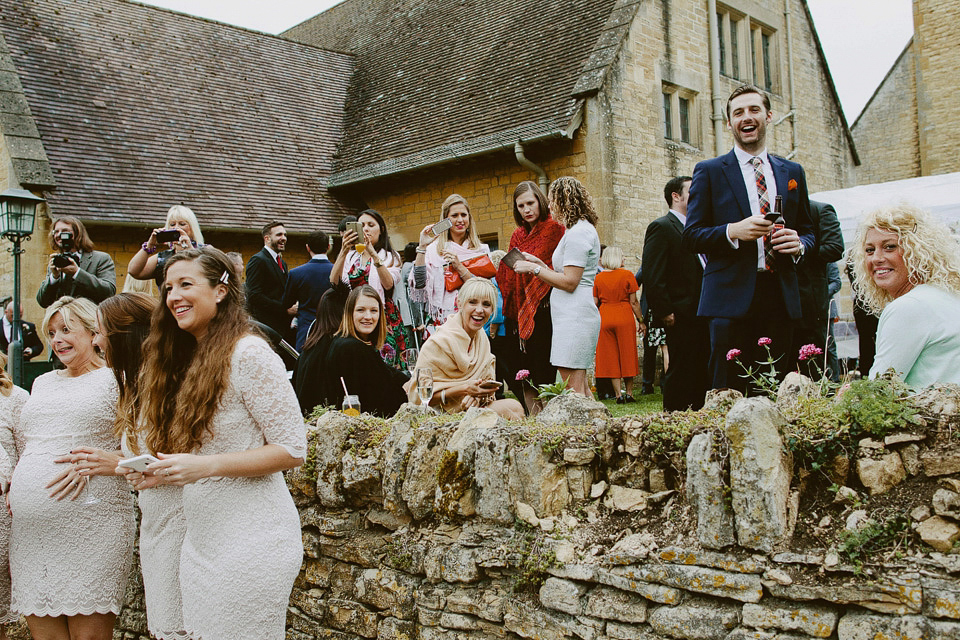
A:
[246,222,297,342]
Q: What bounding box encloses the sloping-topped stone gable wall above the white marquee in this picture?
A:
[851,42,921,184]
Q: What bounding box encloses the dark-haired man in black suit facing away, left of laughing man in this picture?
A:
[643,176,710,411]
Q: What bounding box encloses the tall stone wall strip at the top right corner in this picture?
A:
[913,0,960,176]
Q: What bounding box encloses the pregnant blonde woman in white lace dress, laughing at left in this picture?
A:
[9,297,134,640]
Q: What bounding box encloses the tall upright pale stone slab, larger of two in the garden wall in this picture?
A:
[726,398,793,553]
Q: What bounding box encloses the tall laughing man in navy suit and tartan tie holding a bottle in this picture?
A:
[683,85,814,390]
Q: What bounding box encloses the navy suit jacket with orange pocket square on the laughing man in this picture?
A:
[683,150,815,320]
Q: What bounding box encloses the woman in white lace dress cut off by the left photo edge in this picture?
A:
[0,353,30,640]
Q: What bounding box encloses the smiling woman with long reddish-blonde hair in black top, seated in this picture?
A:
[308,285,407,418]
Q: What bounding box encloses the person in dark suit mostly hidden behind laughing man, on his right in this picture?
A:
[791,200,843,378]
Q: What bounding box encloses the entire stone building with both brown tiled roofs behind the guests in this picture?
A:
[0,0,858,358]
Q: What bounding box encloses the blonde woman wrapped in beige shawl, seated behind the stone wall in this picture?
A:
[407,278,524,420]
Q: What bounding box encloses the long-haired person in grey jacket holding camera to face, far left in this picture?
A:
[37,216,117,308]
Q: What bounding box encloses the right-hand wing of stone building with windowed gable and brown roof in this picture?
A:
[283,0,857,258]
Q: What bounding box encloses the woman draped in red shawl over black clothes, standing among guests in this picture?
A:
[497,181,564,415]
